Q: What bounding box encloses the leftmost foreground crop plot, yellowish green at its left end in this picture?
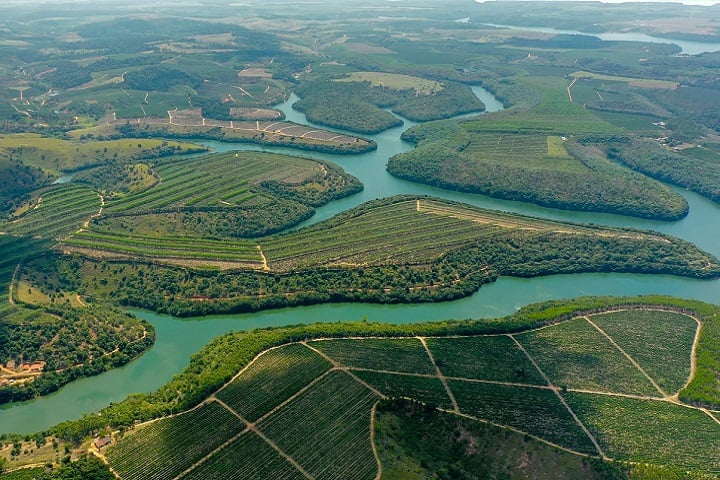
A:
[107,402,244,480]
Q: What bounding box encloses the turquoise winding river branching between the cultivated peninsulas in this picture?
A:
[0,87,720,433]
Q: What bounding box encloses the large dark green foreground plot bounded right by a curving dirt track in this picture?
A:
[258,371,378,480]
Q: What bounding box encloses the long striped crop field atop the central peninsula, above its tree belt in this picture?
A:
[56,194,718,280]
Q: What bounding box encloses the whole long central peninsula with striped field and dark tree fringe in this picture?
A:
[33,197,720,315]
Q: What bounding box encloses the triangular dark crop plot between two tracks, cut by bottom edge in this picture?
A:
[182,431,305,480]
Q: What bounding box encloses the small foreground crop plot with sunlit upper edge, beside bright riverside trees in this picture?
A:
[217,344,331,422]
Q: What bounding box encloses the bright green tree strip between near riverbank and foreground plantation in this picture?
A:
[32,296,720,474]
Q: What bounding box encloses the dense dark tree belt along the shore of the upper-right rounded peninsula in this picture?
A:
[387,133,688,220]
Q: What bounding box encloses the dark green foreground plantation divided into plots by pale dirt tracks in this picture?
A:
[108,307,720,479]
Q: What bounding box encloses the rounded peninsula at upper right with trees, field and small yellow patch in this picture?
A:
[387,126,688,220]
